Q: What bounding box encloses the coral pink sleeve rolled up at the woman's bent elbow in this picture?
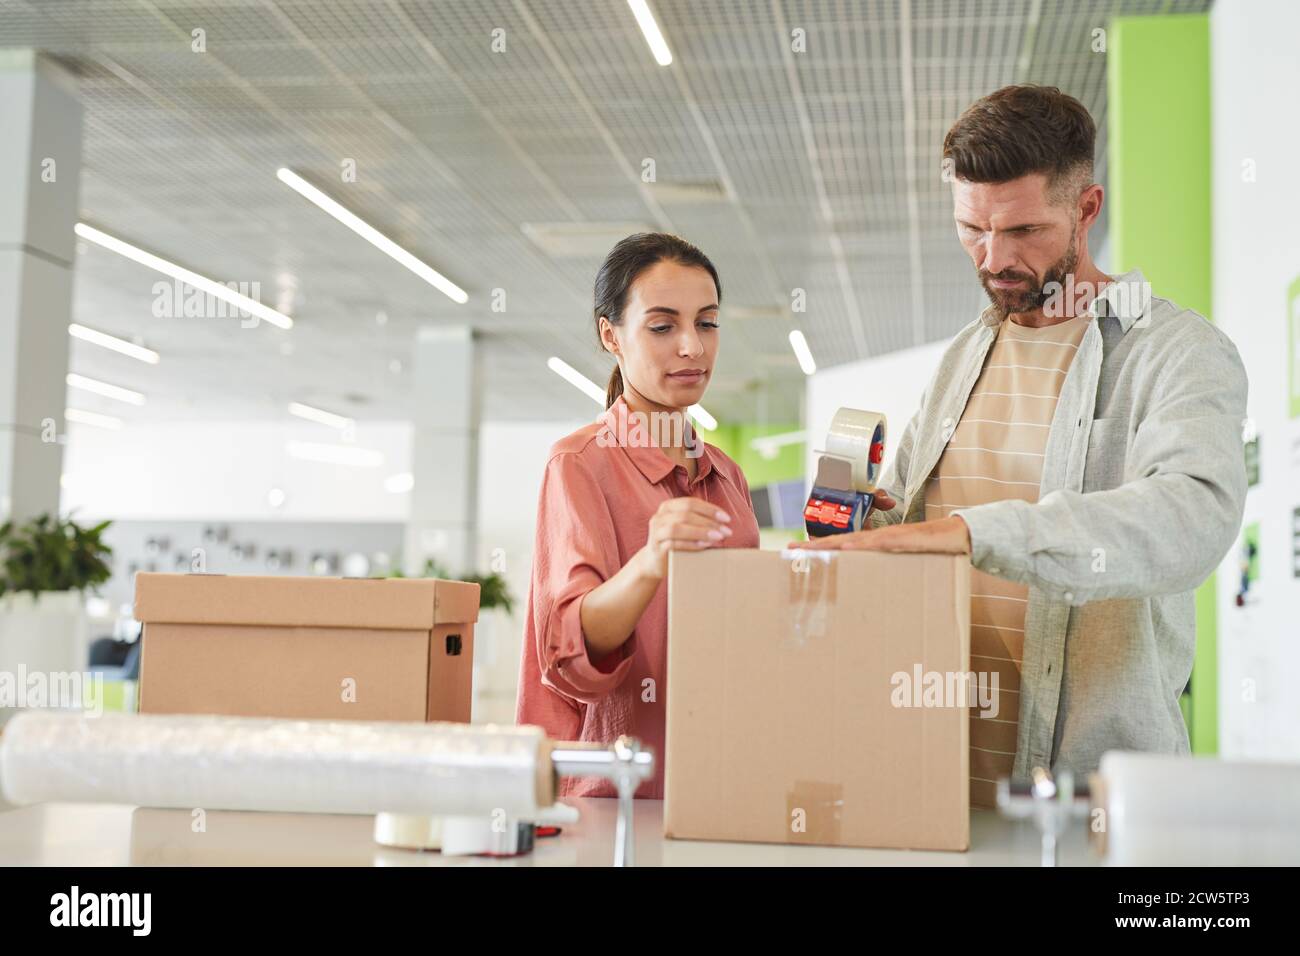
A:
[529,454,636,704]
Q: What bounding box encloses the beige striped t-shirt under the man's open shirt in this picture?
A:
[926,315,1089,806]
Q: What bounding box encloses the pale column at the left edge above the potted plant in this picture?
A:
[0,49,82,523]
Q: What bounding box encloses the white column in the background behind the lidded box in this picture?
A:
[404,326,482,575]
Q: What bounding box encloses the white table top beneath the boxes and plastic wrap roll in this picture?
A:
[0,799,1099,866]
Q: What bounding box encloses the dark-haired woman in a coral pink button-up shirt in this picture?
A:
[516,233,758,797]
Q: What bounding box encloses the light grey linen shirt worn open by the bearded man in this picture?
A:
[870,269,1247,779]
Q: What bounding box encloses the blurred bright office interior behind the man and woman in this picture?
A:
[0,0,1300,757]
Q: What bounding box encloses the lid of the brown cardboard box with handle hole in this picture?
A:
[135,571,478,631]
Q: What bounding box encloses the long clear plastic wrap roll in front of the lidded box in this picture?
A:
[0,710,554,818]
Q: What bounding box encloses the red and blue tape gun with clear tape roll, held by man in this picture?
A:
[803,408,885,537]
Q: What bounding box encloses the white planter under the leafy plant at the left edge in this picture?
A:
[0,591,90,723]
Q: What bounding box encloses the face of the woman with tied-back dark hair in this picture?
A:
[601,261,719,408]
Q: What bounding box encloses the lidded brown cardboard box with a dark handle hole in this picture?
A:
[135,572,478,723]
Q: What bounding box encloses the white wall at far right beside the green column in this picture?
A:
[1210,0,1300,760]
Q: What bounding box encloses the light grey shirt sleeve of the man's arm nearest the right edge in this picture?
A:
[953,323,1247,605]
